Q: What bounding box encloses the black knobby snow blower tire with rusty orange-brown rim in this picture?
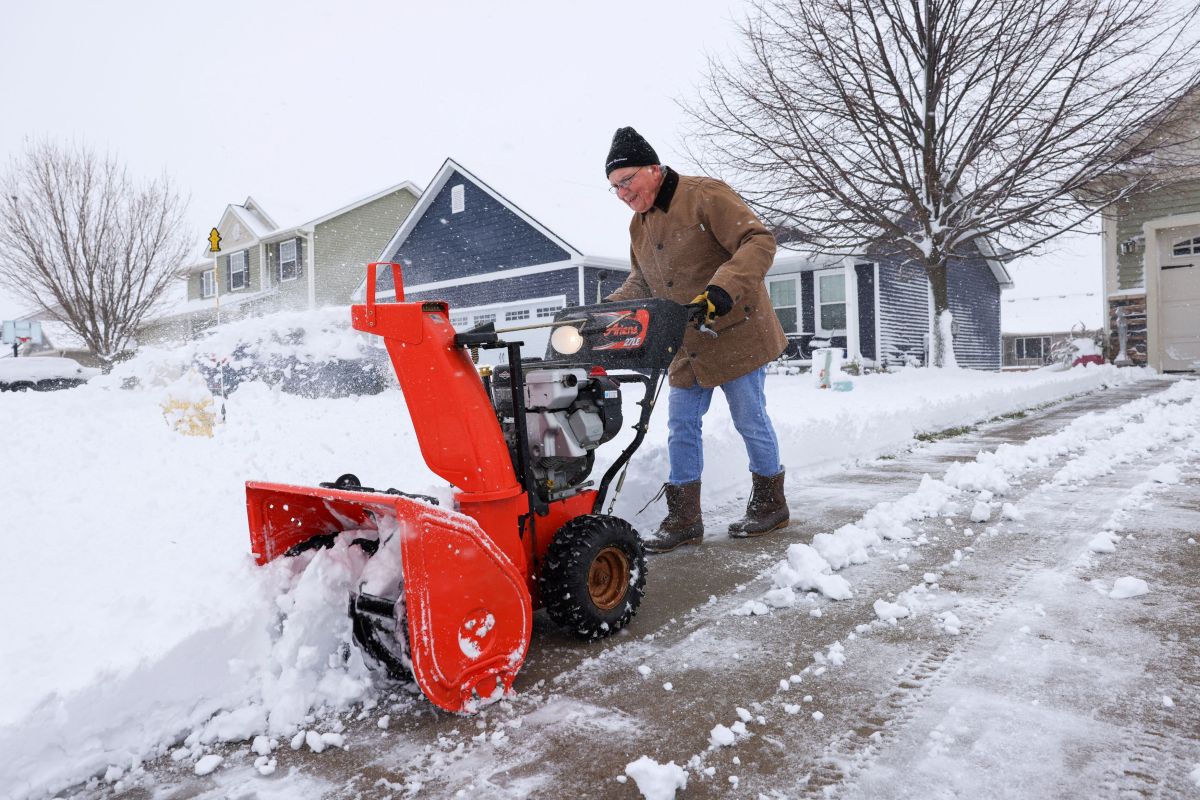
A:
[540,515,646,640]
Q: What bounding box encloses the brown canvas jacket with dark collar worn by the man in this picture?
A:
[607,167,787,389]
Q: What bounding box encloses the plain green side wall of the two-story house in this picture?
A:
[314,190,416,307]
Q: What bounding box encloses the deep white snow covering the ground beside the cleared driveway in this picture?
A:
[0,321,1150,798]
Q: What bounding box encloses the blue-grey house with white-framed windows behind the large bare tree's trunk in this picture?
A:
[767,242,1013,369]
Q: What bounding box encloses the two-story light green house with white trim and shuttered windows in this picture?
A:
[139,181,421,342]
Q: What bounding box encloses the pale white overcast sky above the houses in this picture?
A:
[0,0,1098,319]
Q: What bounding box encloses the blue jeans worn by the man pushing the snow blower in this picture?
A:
[667,367,784,486]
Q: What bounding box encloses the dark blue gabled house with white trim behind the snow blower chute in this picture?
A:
[356,158,630,354]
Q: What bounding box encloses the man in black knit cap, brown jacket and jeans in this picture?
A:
[605,127,788,553]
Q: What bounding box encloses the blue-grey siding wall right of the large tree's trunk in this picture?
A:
[946,248,1001,369]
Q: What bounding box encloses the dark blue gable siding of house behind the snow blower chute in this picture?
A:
[384,172,578,292]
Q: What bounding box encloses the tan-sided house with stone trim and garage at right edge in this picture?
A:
[1100,88,1200,372]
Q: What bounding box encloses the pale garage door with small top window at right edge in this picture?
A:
[1158,230,1200,371]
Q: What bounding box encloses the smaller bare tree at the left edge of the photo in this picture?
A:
[0,143,191,362]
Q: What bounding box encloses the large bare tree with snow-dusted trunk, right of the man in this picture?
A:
[689,0,1200,365]
